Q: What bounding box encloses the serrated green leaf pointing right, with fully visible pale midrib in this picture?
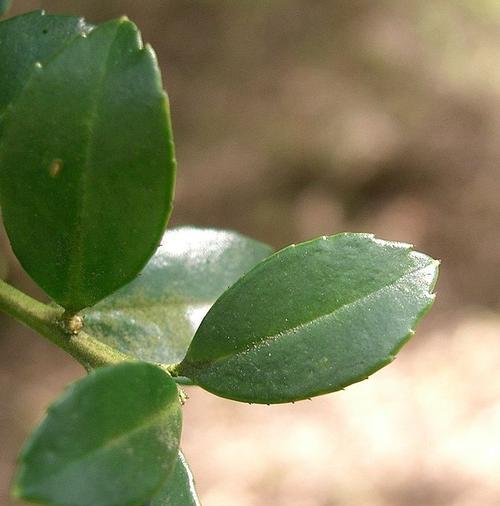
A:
[177,234,438,403]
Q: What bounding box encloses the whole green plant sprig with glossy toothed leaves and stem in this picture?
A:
[0,7,438,506]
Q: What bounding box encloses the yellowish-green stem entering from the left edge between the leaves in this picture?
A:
[0,280,130,370]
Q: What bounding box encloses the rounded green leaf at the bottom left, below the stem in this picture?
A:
[13,362,181,506]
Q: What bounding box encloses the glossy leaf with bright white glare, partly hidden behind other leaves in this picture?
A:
[84,227,272,364]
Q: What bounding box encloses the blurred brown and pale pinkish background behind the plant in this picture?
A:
[0,0,500,506]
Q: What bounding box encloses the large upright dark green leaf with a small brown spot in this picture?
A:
[0,15,175,312]
